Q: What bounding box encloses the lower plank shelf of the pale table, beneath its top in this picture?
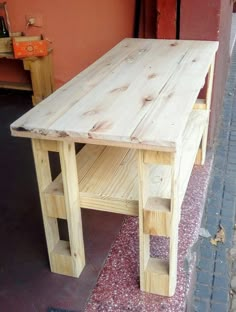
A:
[44,111,208,221]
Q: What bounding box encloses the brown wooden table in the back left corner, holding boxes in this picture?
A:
[0,50,55,105]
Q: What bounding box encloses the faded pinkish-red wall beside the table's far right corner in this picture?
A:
[180,0,232,144]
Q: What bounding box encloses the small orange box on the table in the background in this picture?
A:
[12,36,48,58]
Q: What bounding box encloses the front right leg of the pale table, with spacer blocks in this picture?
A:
[138,150,180,296]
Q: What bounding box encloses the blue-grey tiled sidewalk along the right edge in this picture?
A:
[191,42,236,312]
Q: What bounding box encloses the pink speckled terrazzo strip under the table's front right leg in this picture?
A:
[85,157,212,312]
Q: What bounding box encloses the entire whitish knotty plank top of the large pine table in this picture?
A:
[11,39,218,151]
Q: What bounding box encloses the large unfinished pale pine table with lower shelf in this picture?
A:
[11,39,218,296]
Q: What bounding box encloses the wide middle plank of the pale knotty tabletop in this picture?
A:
[49,40,192,141]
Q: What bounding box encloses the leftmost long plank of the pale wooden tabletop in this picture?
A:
[10,39,155,130]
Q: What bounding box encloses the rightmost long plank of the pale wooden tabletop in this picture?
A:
[131,42,218,146]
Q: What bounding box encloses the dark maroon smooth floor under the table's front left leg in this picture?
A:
[0,90,124,312]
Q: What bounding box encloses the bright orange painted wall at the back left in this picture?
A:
[0,0,135,87]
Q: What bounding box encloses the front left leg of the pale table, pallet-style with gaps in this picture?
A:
[32,139,85,277]
